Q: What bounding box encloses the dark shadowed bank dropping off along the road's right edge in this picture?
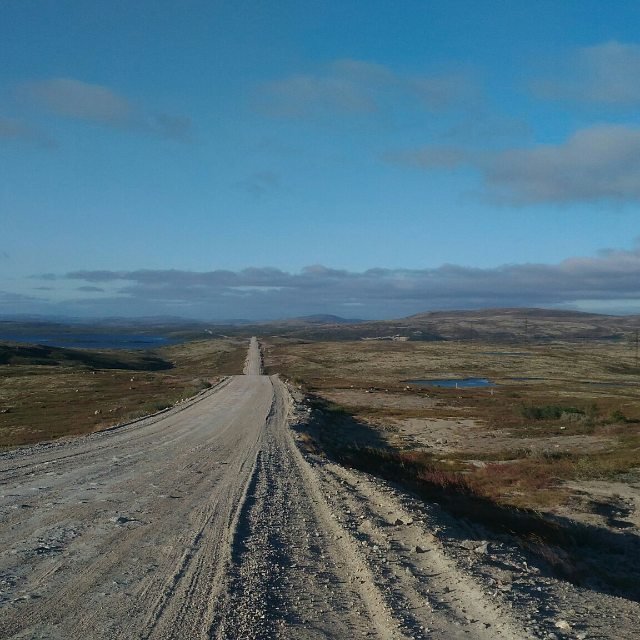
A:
[294,395,640,600]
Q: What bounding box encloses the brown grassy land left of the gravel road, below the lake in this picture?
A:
[0,340,247,448]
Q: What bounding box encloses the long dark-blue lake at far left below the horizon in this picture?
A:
[0,331,177,349]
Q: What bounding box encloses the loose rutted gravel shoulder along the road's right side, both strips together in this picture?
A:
[211,378,528,640]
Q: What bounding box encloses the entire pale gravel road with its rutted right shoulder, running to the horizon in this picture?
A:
[0,339,637,640]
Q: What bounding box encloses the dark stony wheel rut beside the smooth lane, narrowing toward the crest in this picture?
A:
[211,378,404,640]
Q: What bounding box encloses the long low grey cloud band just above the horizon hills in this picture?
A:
[66,240,640,317]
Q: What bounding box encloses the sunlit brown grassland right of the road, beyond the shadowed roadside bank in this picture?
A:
[265,339,640,509]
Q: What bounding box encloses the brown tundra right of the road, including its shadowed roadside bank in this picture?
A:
[264,339,640,598]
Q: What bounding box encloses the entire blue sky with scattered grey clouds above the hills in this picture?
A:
[0,0,640,319]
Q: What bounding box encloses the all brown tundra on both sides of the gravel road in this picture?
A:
[0,318,640,598]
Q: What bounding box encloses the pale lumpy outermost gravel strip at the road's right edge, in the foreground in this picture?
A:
[316,462,527,640]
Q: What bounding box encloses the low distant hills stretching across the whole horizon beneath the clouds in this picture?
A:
[0,308,640,342]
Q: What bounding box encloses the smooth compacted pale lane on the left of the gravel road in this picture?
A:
[0,348,273,640]
